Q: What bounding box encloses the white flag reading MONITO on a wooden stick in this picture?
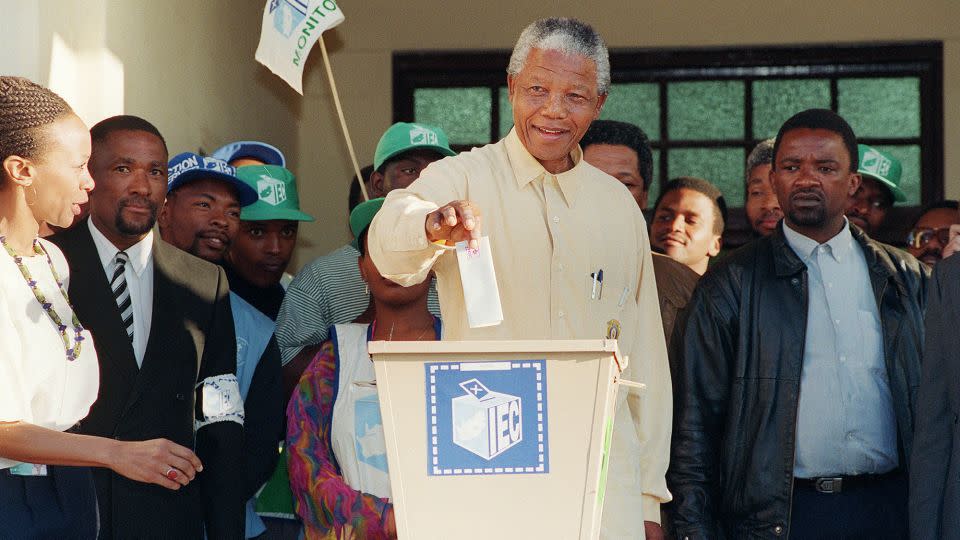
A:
[256,0,344,95]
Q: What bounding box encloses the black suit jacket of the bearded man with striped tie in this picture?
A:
[51,220,244,539]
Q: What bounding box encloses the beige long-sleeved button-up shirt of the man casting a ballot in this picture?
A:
[368,127,673,538]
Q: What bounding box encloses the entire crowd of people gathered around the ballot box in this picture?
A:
[0,14,960,539]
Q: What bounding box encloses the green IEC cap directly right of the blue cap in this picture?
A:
[237,165,313,221]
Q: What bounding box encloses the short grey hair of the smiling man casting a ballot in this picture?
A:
[507,17,610,95]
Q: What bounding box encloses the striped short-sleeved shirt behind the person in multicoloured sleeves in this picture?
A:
[276,244,440,365]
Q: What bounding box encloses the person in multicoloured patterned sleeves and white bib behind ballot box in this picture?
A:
[287,199,440,539]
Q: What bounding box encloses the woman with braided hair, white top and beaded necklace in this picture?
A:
[0,76,201,539]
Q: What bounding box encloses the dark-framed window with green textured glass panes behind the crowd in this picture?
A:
[394,42,943,244]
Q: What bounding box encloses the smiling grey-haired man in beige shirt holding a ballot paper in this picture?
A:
[369,19,671,538]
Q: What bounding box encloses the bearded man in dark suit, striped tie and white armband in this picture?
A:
[52,116,243,539]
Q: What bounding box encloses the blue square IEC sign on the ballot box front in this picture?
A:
[424,360,550,476]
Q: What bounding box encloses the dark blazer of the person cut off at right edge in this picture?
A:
[910,255,960,540]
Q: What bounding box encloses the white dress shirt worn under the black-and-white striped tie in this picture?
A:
[87,219,153,366]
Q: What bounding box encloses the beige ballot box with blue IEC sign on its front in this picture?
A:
[369,340,627,540]
